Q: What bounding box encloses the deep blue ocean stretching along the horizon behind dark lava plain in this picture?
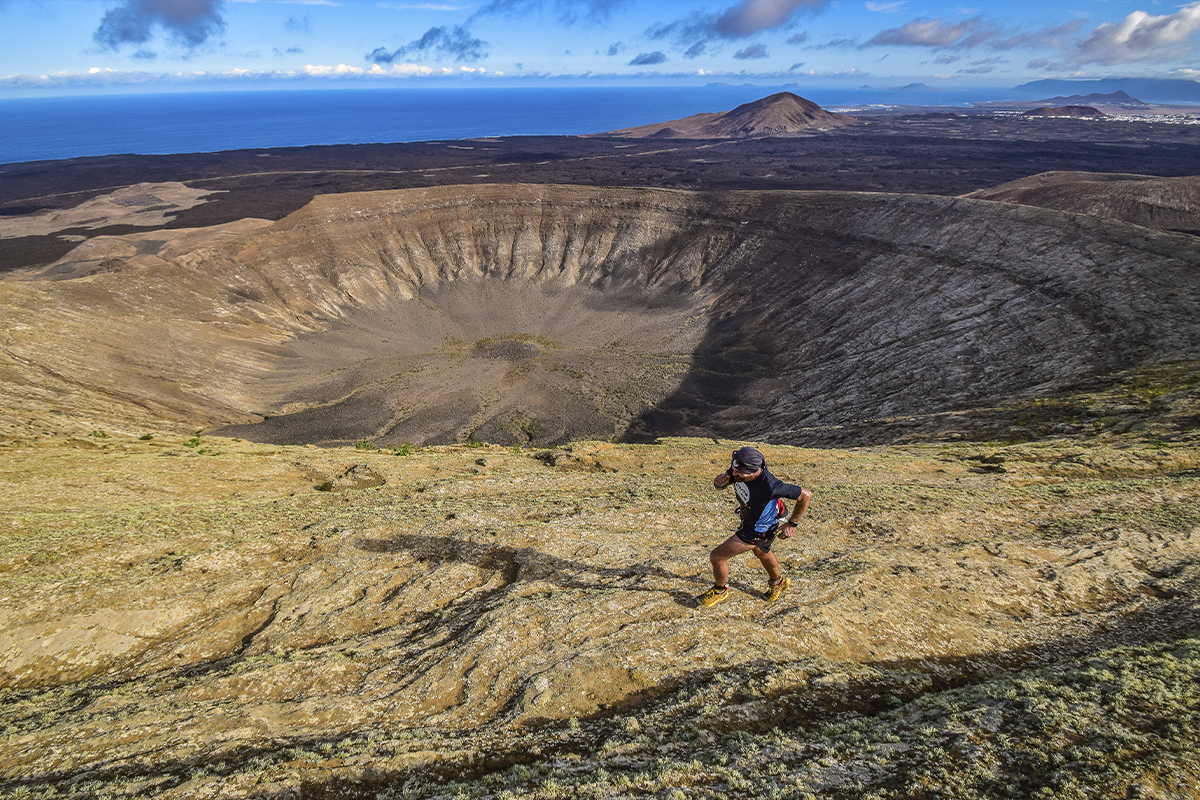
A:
[0,85,1012,163]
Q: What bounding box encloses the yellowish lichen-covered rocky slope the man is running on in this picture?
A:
[0,410,1200,798]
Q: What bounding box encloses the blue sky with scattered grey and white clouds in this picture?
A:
[0,0,1200,96]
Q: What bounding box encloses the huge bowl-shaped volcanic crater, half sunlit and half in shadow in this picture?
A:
[0,185,1200,445]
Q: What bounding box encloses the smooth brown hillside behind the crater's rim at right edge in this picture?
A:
[964,172,1200,231]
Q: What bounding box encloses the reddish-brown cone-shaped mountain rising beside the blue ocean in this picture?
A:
[595,91,854,139]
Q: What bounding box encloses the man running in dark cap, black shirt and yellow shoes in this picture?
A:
[700,447,812,606]
